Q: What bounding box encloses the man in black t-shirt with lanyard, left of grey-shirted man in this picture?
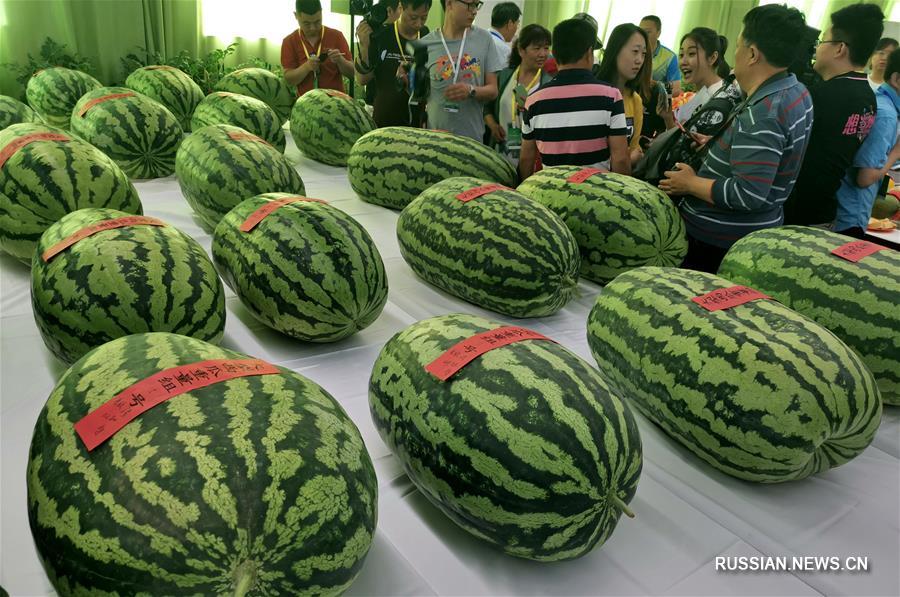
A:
[356,0,432,127]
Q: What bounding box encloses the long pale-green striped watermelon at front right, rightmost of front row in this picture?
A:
[588,267,881,483]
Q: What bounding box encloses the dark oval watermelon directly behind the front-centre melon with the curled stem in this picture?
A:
[212,193,388,342]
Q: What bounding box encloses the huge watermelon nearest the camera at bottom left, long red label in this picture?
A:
[26,333,378,595]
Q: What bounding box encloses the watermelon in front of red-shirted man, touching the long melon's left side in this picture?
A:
[291,89,375,166]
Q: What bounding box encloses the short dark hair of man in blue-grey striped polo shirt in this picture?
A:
[741,4,806,68]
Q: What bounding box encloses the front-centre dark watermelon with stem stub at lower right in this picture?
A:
[369,315,641,561]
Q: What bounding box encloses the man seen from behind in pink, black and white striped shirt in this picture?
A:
[519,19,631,180]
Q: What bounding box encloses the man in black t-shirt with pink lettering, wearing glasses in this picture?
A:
[784,4,884,225]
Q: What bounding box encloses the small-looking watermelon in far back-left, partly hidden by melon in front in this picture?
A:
[25,66,103,130]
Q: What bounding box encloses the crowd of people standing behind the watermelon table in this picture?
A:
[282,0,900,272]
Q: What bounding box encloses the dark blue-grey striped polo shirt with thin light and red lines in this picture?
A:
[681,73,813,248]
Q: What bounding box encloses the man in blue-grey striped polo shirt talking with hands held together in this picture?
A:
[659,4,813,272]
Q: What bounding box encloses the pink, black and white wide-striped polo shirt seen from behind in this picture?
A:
[522,69,628,167]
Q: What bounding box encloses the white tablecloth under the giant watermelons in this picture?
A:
[0,136,900,595]
